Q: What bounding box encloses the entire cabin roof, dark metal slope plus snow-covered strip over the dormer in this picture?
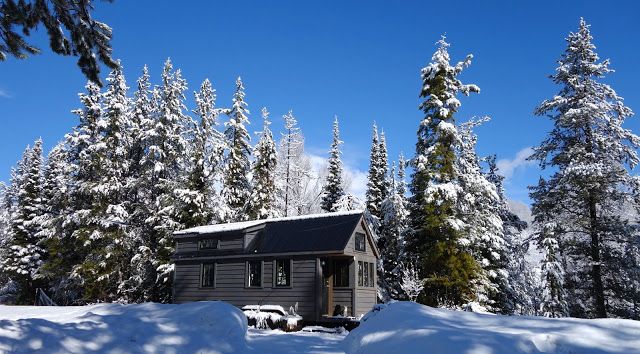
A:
[174,210,366,254]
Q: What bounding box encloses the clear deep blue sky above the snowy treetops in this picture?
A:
[0,0,640,202]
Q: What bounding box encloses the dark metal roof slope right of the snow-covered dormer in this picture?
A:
[247,214,362,253]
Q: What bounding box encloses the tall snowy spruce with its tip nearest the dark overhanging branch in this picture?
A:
[77,63,133,301]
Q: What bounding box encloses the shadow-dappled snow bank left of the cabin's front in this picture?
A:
[0,301,247,353]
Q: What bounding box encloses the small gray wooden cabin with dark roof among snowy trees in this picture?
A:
[173,211,379,321]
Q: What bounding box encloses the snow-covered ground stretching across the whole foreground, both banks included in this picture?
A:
[0,302,640,354]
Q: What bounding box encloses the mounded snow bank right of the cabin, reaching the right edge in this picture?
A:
[343,302,640,354]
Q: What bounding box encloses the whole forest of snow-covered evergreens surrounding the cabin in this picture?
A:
[0,19,640,319]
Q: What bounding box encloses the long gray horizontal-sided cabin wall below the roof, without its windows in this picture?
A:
[174,257,316,319]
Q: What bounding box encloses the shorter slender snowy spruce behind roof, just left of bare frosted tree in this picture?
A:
[246,107,278,220]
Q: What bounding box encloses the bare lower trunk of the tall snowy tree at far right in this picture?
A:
[589,191,607,318]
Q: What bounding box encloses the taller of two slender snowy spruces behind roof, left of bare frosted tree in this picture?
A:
[222,77,251,222]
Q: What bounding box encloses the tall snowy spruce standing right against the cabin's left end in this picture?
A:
[134,60,191,302]
